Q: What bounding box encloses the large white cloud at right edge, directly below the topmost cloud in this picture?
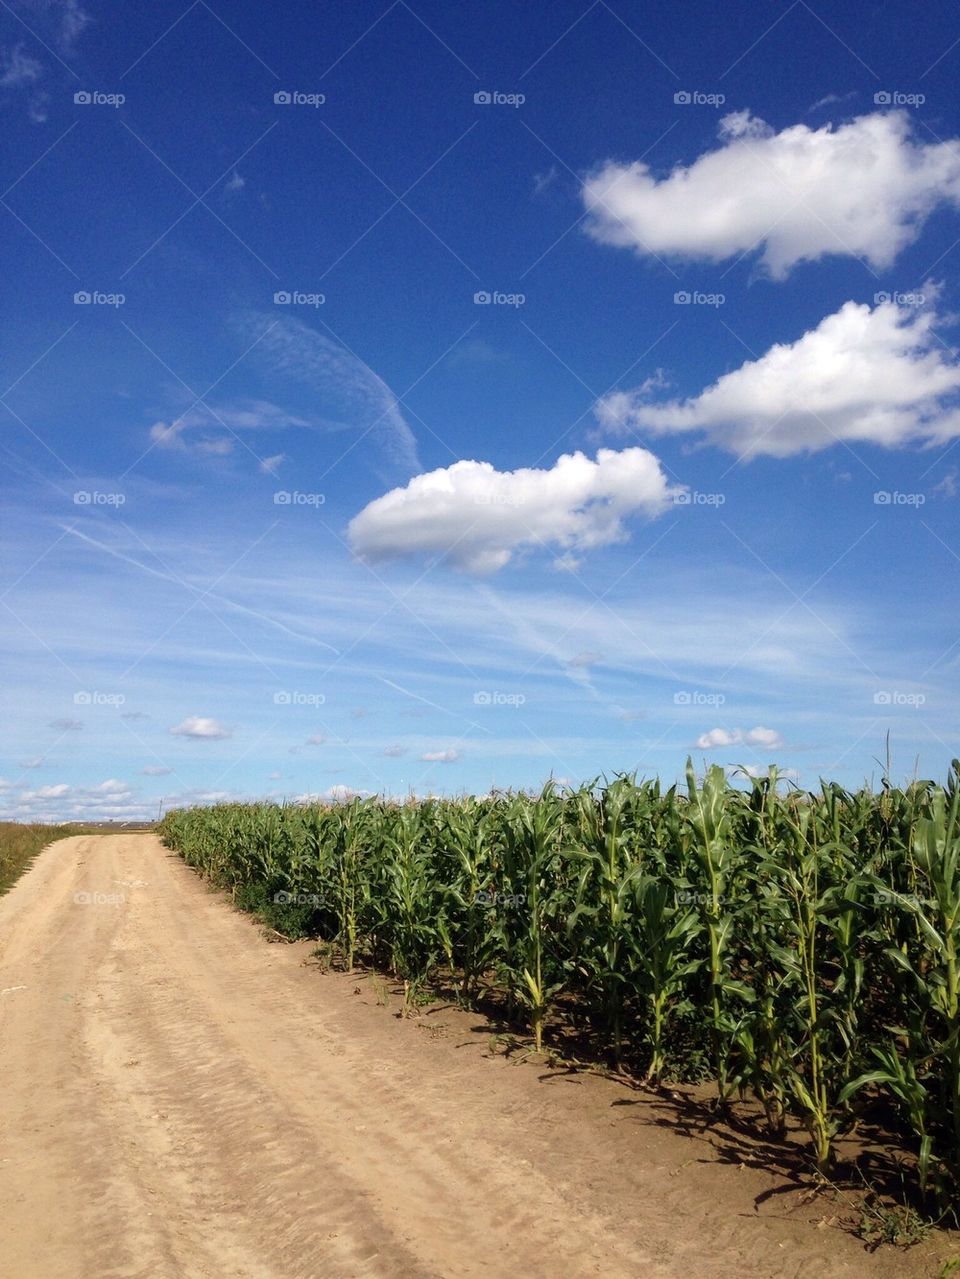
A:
[596,294,960,458]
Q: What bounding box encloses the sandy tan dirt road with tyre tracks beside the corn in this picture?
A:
[0,834,934,1279]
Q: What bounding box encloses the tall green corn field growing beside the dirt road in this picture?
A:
[160,760,960,1214]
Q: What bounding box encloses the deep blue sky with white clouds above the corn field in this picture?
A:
[0,0,960,819]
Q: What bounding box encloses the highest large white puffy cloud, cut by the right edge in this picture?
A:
[582,111,960,279]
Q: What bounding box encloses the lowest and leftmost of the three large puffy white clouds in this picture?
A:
[349,448,679,573]
